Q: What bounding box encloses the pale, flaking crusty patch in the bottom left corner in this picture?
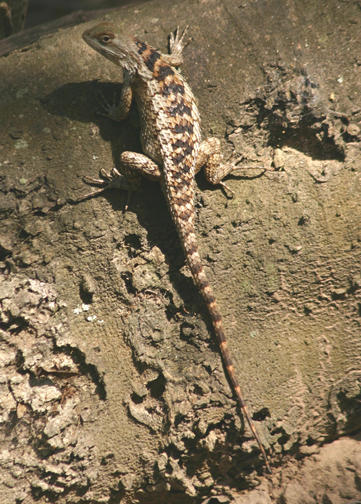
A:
[0,274,104,503]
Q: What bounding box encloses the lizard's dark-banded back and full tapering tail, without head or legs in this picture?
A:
[155,60,270,471]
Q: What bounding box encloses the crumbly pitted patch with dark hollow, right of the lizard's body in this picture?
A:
[243,66,346,162]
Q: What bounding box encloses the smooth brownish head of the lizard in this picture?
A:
[83,23,149,76]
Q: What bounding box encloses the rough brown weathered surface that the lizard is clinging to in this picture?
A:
[0,0,361,504]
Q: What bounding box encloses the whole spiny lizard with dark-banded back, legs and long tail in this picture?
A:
[79,22,271,472]
